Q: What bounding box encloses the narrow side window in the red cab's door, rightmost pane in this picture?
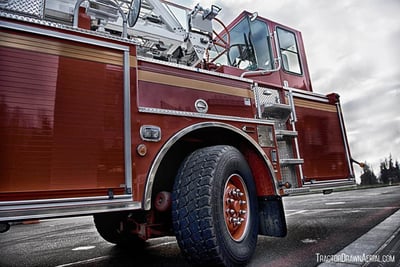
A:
[277,28,302,74]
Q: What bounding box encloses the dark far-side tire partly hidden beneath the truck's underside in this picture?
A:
[93,212,145,248]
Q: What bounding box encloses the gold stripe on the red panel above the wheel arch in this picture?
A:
[139,70,253,98]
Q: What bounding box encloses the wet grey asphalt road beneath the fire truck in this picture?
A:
[0,186,400,267]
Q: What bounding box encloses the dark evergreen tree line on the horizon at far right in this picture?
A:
[360,155,400,185]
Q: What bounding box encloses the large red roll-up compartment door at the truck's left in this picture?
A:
[0,31,125,200]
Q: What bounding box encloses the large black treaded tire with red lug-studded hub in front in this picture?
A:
[172,146,258,266]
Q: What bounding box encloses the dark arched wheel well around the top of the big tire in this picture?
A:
[145,124,276,209]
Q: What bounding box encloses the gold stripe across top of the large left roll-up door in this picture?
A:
[0,32,123,66]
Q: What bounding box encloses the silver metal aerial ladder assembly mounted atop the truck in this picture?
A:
[44,0,229,66]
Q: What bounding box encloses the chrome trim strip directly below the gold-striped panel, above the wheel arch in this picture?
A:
[139,107,274,125]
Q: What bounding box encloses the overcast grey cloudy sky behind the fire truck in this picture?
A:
[174,0,400,180]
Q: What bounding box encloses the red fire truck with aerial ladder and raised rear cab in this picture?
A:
[0,0,360,266]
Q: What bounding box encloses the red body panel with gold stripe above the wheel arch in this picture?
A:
[137,62,255,118]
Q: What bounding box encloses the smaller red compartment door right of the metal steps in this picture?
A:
[294,98,352,183]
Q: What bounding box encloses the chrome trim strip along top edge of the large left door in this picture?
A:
[0,20,129,51]
